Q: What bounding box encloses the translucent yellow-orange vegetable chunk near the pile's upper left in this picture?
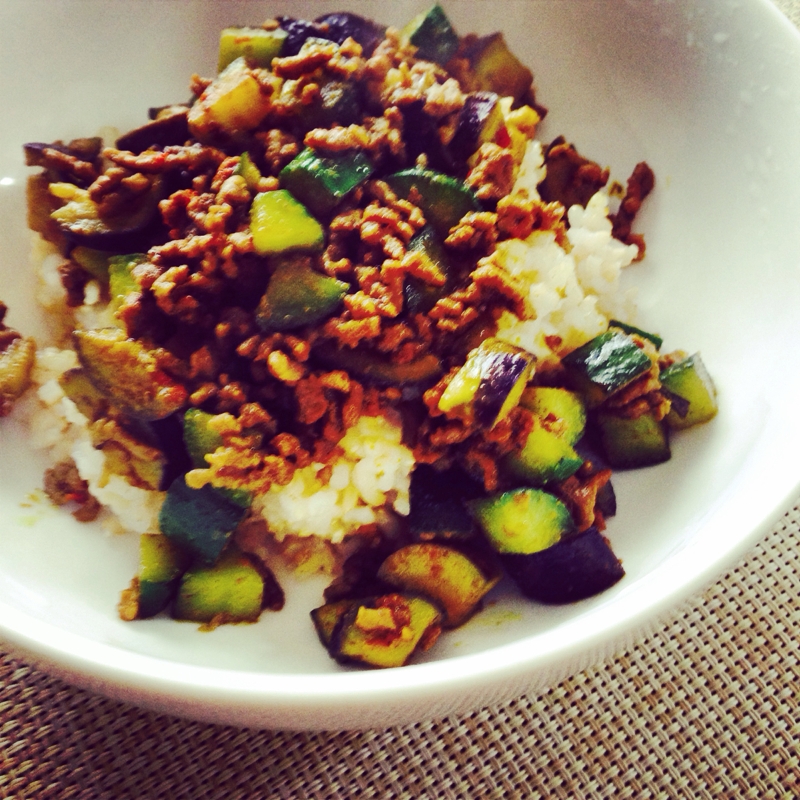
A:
[187,58,272,142]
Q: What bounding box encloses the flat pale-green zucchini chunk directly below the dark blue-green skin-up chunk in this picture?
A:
[172,549,283,625]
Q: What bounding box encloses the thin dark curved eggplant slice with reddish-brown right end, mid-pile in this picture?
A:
[313,344,444,386]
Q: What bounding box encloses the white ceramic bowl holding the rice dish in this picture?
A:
[0,0,800,729]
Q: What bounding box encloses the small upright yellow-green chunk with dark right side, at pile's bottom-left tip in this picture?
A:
[119,533,189,620]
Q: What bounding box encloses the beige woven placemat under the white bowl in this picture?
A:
[0,0,800,800]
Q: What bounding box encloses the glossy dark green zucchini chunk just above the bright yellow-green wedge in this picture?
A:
[280,147,374,217]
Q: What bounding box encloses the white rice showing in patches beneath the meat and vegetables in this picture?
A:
[23,136,638,543]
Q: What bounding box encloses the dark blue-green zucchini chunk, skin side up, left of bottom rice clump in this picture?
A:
[158,475,245,565]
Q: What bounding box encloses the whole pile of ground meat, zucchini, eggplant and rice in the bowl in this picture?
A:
[0,5,716,667]
